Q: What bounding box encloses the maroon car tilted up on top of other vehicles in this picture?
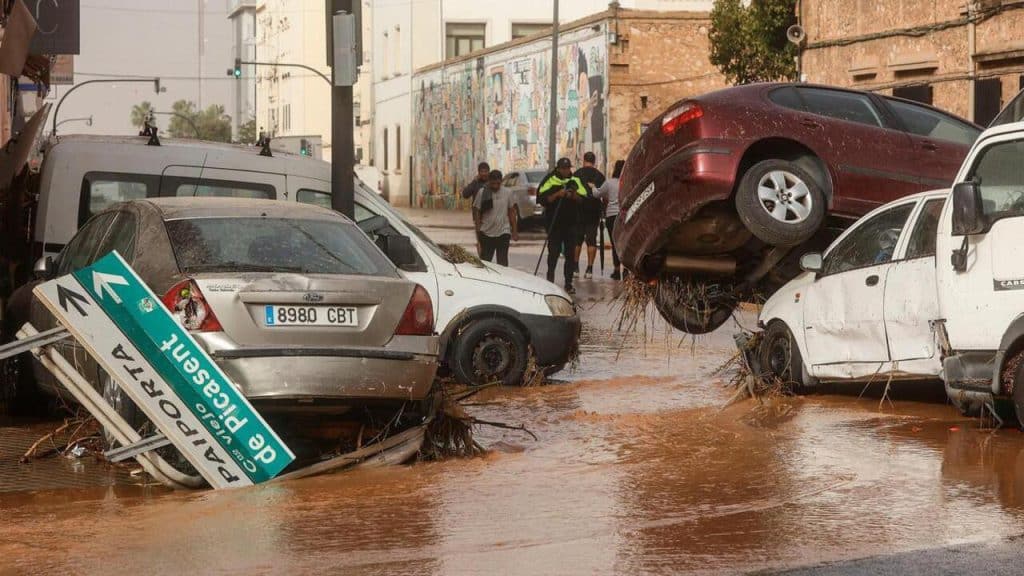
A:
[614,84,981,333]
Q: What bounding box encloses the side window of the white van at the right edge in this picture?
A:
[968,140,1024,219]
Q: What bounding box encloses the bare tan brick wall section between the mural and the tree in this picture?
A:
[608,12,727,163]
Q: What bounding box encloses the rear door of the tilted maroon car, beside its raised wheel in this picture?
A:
[794,87,922,215]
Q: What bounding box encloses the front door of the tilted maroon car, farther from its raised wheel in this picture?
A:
[885,98,981,189]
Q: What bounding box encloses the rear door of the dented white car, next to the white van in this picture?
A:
[884,198,945,362]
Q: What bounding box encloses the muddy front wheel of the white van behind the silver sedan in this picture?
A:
[451,318,529,386]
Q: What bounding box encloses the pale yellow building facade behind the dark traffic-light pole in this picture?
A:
[249,0,373,163]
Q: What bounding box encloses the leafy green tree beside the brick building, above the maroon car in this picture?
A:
[708,0,797,84]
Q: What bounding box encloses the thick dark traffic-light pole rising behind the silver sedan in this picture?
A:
[327,0,362,218]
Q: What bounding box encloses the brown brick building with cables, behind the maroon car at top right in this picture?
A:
[798,0,1024,125]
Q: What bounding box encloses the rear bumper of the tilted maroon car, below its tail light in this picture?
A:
[614,140,738,275]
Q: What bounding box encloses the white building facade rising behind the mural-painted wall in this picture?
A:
[364,0,712,204]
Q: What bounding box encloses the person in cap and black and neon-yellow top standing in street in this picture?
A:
[537,158,587,294]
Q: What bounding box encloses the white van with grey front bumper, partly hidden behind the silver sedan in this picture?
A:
[24,135,581,384]
